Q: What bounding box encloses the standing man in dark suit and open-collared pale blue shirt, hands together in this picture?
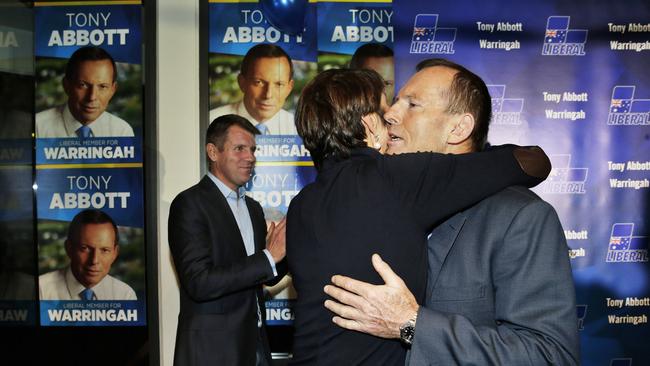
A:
[169,114,286,366]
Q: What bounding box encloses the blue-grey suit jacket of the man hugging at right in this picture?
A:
[407,187,580,366]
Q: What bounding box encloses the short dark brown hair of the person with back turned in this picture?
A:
[296,69,384,169]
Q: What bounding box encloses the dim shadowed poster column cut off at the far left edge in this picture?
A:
[0,2,38,327]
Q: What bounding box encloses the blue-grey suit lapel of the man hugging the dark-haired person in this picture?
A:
[427,212,467,298]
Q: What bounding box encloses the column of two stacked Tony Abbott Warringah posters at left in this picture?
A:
[34,1,146,326]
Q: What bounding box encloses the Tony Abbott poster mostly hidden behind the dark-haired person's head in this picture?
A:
[318,0,395,101]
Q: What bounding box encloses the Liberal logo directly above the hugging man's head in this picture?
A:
[410,14,456,54]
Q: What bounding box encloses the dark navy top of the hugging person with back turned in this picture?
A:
[287,148,537,366]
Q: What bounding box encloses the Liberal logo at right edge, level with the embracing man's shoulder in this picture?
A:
[605,223,648,262]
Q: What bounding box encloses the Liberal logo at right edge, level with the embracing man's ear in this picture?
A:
[607,85,650,126]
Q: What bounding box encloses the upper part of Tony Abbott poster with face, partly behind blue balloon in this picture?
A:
[208,0,316,135]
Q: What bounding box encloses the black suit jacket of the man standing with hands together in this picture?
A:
[169,176,283,366]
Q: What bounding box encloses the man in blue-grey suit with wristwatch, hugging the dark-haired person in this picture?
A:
[325,59,580,365]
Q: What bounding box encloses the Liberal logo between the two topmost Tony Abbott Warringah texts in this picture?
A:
[542,16,587,56]
